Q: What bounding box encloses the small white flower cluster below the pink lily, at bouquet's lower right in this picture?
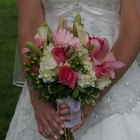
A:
[96,76,111,90]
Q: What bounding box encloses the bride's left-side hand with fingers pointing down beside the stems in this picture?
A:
[34,101,64,139]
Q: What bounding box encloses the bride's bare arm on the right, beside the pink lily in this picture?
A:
[96,0,140,100]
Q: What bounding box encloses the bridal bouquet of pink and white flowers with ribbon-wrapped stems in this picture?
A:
[22,14,125,140]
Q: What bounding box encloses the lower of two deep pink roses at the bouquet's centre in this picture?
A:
[58,65,78,89]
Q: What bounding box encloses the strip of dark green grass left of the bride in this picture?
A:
[0,0,21,140]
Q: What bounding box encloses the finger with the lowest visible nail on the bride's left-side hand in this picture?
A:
[42,118,58,139]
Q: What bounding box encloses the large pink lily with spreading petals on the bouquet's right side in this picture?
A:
[87,37,125,79]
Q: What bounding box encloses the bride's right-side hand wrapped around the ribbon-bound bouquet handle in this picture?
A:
[59,103,94,132]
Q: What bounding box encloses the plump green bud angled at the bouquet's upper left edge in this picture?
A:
[26,41,43,57]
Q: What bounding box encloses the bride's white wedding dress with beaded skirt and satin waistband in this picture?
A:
[6,0,140,140]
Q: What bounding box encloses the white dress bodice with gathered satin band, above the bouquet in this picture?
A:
[42,0,121,47]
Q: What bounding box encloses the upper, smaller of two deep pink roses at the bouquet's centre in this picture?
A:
[51,47,67,64]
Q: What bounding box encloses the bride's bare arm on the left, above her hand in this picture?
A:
[17,0,44,106]
